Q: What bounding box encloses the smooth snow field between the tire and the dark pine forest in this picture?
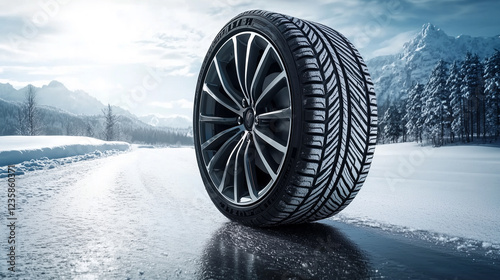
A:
[334,143,500,247]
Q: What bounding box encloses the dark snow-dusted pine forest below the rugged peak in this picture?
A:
[378,50,500,146]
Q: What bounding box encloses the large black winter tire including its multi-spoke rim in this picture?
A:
[193,10,377,226]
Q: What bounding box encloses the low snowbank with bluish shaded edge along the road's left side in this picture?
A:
[0,136,130,178]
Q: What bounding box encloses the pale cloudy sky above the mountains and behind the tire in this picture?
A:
[0,0,500,117]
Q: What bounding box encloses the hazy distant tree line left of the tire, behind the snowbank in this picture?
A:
[8,88,193,145]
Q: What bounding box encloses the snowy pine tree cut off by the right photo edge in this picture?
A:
[484,50,500,140]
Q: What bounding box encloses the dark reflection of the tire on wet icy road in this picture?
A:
[197,223,371,279]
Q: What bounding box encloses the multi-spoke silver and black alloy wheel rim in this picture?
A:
[196,32,292,205]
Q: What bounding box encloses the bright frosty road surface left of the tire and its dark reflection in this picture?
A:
[2,149,226,278]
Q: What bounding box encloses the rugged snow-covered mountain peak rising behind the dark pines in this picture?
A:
[366,23,500,105]
